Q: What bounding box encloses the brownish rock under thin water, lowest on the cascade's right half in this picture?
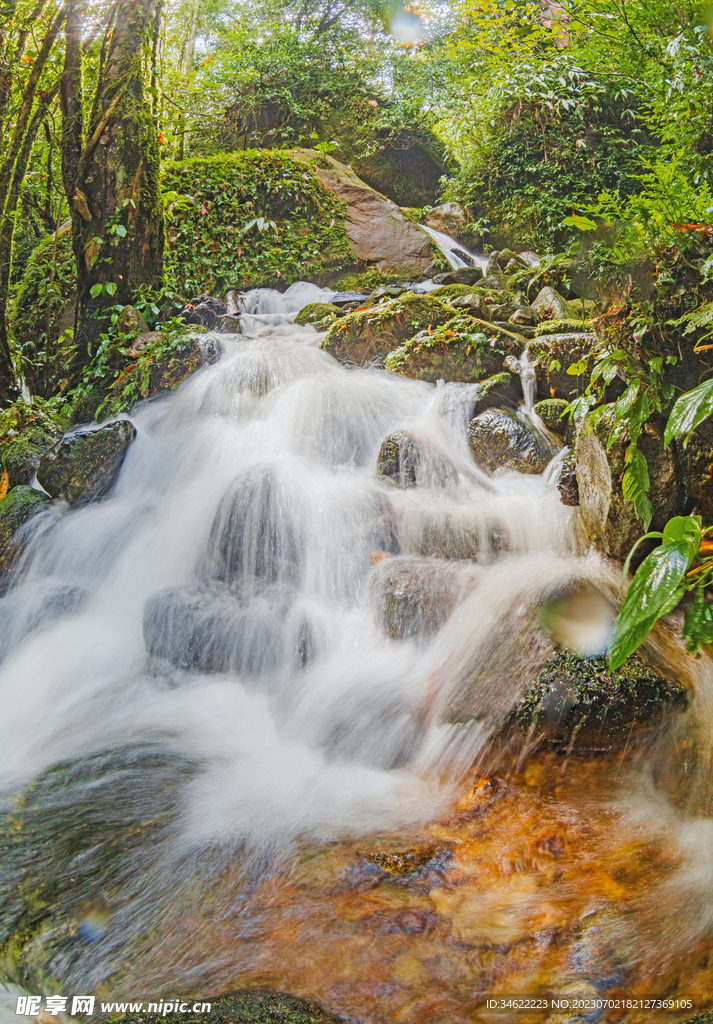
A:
[370,556,478,640]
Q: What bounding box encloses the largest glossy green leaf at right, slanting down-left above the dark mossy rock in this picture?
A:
[609,542,689,671]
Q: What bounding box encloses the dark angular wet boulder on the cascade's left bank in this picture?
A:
[37,420,136,508]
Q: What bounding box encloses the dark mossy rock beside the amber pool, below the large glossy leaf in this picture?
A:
[512,650,688,750]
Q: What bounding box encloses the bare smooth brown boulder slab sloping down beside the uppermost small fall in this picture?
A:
[289,150,433,276]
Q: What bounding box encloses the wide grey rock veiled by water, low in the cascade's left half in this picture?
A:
[143,582,311,676]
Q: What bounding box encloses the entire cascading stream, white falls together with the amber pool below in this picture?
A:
[0,285,711,1024]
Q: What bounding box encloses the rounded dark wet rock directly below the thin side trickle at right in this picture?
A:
[468,409,557,473]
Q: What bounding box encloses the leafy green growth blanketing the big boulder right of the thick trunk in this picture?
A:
[163,150,354,295]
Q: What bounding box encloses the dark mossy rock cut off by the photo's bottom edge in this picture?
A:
[109,989,341,1024]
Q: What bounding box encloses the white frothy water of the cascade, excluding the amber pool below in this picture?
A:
[0,285,710,1003]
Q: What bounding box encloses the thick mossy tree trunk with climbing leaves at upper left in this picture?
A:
[62,0,164,362]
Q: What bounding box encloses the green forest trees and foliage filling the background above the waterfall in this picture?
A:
[0,0,713,647]
